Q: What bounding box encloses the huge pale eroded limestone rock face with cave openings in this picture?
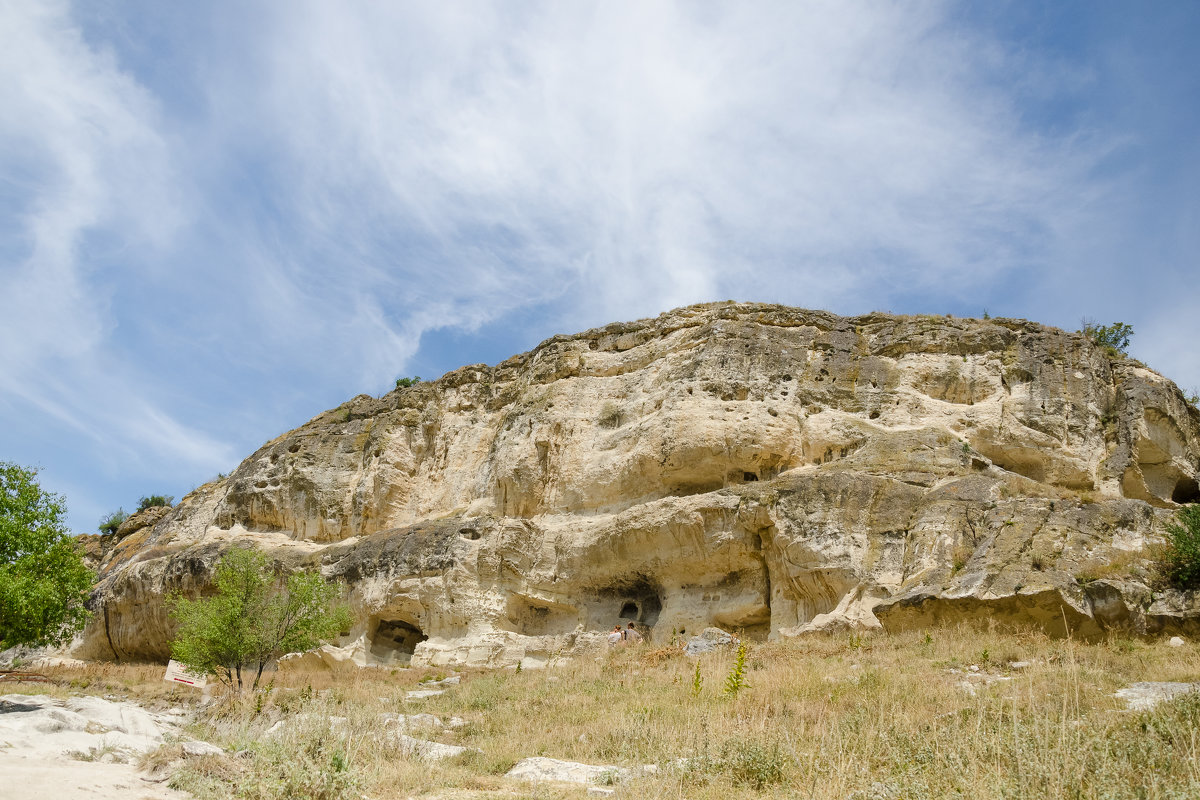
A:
[78,303,1200,666]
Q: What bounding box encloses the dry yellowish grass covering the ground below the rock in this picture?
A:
[28,627,1200,800]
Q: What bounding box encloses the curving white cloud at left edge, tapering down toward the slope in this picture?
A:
[0,2,229,463]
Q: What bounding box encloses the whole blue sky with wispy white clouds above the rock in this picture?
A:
[0,0,1200,533]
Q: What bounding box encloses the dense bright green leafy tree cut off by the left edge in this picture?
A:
[0,462,95,649]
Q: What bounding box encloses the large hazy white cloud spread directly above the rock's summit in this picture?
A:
[194,2,1098,361]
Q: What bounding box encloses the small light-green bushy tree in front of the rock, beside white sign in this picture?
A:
[172,547,350,692]
